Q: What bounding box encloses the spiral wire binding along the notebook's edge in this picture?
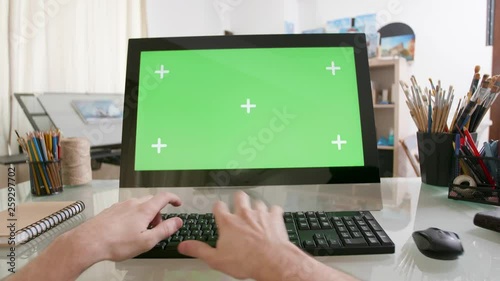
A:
[16,201,85,244]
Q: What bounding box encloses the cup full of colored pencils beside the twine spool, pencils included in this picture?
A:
[16,131,63,196]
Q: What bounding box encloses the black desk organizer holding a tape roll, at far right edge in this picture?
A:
[448,156,500,206]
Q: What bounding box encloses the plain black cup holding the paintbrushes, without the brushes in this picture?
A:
[417,132,455,187]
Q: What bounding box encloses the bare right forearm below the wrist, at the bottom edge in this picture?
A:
[256,244,357,281]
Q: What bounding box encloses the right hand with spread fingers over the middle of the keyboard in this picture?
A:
[178,189,292,279]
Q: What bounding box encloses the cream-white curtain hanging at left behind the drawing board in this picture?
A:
[0,0,147,155]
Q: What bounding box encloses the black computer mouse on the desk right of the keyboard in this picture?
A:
[412,227,464,260]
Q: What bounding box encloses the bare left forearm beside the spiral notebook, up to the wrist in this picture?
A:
[6,230,98,281]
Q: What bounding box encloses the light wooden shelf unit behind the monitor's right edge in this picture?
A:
[369,58,416,177]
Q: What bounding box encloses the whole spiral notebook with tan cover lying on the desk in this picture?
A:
[0,201,85,247]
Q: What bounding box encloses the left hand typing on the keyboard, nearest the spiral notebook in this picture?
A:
[69,192,182,261]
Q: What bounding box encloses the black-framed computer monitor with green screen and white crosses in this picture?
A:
[120,34,380,187]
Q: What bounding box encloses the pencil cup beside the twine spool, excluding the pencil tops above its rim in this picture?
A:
[27,161,63,196]
